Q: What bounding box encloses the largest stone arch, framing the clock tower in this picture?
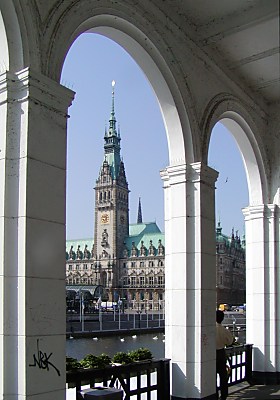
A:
[45,9,197,165]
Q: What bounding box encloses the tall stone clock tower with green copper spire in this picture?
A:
[94,81,129,297]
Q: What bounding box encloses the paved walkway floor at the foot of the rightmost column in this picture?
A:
[228,383,280,400]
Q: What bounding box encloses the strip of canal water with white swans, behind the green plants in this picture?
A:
[66,332,165,360]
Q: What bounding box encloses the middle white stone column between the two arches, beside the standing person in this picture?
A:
[161,163,218,400]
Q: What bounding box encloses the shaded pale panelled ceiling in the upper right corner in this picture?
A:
[154,0,280,103]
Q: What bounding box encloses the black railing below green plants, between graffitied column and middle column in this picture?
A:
[66,358,170,400]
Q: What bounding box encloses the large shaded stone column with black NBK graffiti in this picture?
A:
[0,69,73,400]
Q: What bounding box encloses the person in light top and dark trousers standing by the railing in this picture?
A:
[216,310,234,400]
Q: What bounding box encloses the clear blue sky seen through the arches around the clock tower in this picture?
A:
[61,34,248,239]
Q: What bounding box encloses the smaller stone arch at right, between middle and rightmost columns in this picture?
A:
[203,94,269,205]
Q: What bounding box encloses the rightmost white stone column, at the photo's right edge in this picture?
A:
[243,204,280,383]
